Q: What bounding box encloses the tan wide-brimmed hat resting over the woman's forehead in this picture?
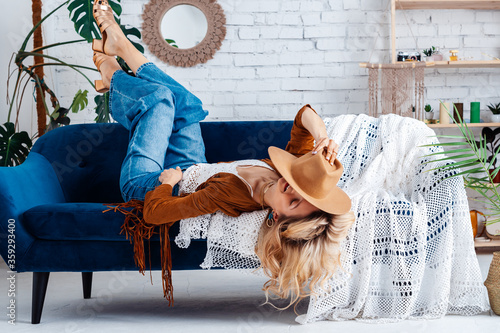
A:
[268,147,351,214]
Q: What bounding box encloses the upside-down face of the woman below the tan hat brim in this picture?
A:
[265,177,319,220]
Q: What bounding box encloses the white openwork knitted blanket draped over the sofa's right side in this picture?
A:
[173,114,489,324]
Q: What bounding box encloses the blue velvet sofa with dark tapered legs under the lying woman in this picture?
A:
[0,121,292,324]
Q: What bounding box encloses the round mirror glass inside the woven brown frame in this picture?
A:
[160,5,208,49]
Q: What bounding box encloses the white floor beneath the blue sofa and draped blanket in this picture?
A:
[0,254,500,333]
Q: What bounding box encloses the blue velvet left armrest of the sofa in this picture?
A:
[0,152,66,262]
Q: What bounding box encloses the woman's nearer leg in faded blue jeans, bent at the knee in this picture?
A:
[110,71,175,201]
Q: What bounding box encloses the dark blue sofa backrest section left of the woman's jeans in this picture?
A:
[31,123,129,203]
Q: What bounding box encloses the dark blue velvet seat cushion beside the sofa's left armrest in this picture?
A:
[23,203,141,241]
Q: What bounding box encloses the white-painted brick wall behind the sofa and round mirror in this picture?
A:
[0,0,500,137]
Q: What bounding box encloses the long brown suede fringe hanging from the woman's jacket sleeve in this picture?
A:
[103,200,174,306]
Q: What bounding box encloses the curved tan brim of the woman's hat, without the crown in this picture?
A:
[268,147,351,214]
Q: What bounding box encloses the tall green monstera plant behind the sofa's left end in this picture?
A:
[4,0,144,166]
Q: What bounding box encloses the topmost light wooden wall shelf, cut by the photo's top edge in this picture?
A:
[396,0,500,10]
